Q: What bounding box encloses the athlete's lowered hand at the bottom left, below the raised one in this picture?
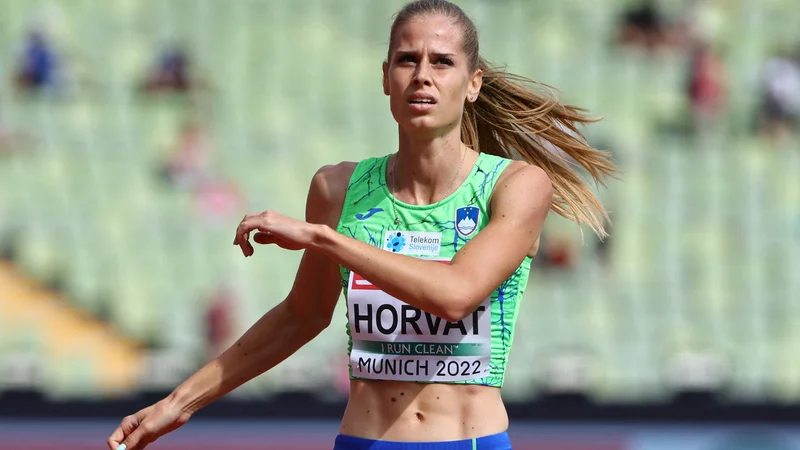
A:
[108,398,191,450]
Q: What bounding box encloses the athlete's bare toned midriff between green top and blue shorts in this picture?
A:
[340,380,508,442]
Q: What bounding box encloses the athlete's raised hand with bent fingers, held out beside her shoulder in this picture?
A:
[233,211,324,257]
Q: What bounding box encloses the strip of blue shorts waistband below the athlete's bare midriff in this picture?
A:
[333,433,511,450]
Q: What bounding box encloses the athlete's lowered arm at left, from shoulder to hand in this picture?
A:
[108,163,354,450]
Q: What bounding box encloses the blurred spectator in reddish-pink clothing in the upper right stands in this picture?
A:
[686,40,726,132]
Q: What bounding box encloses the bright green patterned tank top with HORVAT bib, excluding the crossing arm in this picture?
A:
[337,153,531,387]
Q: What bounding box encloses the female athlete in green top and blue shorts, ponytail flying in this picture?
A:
[108,0,615,450]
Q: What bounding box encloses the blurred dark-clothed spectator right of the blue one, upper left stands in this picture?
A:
[142,47,202,93]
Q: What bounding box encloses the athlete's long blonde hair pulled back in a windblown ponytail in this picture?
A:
[389,0,617,239]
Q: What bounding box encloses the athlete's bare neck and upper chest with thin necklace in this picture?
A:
[388,128,477,205]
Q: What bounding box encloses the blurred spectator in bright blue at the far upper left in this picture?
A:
[14,29,58,91]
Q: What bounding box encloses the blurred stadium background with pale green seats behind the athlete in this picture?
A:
[0,0,800,450]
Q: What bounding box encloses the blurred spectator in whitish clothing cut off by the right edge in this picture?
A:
[759,47,800,143]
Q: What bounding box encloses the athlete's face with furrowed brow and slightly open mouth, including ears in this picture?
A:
[383,16,482,137]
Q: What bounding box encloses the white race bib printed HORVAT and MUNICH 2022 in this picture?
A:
[347,260,492,382]
